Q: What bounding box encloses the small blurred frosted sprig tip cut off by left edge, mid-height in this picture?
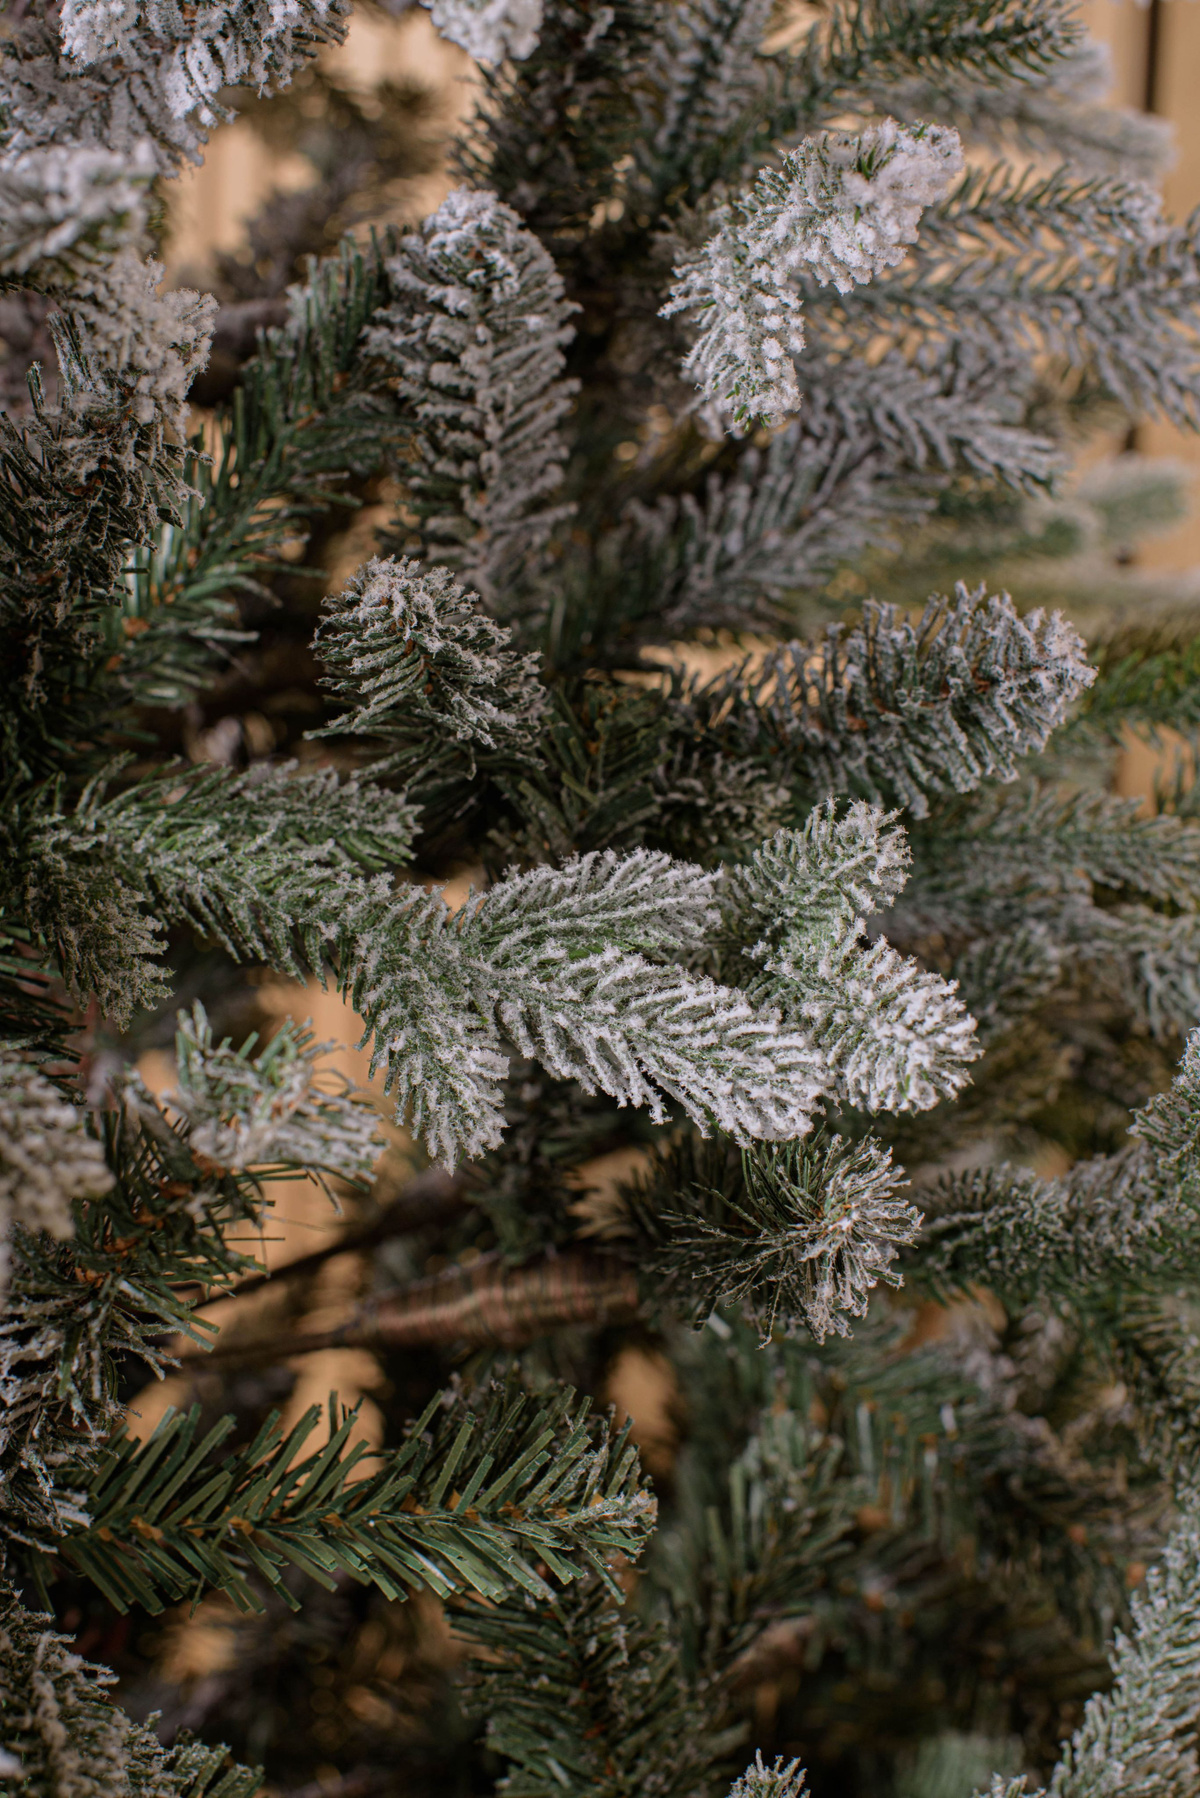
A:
[0,1046,113,1300]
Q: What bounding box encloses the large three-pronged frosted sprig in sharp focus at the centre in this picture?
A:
[329,850,822,1163]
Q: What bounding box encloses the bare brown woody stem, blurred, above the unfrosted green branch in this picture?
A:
[196,1250,639,1363]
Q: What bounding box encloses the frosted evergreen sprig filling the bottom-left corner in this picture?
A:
[0,1589,263,1798]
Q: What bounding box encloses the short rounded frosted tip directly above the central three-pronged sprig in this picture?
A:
[313,557,545,750]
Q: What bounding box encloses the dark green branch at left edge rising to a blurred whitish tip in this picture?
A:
[0,1009,378,1548]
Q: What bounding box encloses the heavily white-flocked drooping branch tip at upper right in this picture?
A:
[662,119,963,426]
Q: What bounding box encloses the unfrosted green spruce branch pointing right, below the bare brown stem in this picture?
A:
[58,1386,655,1611]
